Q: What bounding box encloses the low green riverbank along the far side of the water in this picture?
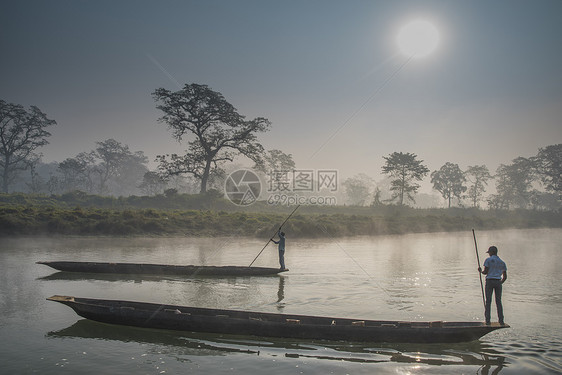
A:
[0,203,562,238]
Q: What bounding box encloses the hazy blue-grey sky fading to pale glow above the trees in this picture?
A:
[0,0,562,188]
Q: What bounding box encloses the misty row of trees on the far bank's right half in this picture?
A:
[343,144,562,210]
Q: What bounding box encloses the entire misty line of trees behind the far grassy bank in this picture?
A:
[0,84,562,209]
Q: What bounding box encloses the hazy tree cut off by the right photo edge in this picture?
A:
[536,143,562,198]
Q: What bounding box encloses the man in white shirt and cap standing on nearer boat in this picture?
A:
[478,246,507,325]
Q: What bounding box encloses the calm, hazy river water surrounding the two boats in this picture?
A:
[0,229,562,375]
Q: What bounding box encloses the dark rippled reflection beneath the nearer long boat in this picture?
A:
[46,319,506,375]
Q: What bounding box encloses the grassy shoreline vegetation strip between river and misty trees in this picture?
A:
[0,192,562,238]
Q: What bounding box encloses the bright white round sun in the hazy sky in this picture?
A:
[397,20,439,58]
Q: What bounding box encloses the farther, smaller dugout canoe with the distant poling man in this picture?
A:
[37,261,288,276]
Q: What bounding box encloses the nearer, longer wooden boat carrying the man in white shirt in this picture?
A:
[47,295,509,343]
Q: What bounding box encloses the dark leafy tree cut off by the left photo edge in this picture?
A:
[0,100,56,193]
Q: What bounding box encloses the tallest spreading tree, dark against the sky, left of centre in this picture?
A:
[152,83,270,193]
